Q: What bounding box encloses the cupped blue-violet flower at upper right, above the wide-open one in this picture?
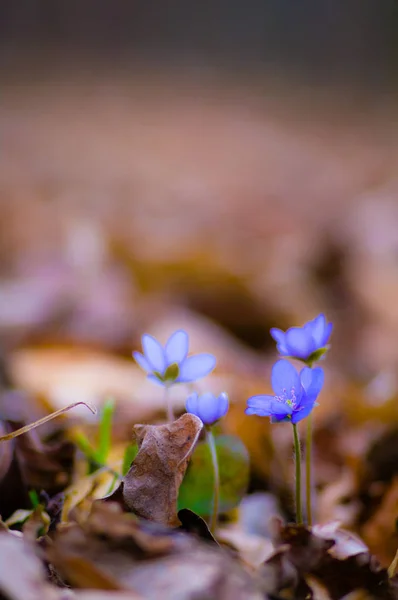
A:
[270,314,333,362]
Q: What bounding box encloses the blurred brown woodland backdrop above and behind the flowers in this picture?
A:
[0,0,398,426]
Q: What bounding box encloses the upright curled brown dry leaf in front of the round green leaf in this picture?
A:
[122,413,203,526]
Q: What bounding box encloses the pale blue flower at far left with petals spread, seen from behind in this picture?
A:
[133,329,216,386]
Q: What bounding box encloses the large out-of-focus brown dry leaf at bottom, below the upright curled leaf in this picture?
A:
[46,502,264,600]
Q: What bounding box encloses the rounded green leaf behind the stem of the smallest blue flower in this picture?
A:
[178,435,249,517]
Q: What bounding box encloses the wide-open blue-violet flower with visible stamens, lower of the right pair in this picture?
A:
[245,360,324,423]
